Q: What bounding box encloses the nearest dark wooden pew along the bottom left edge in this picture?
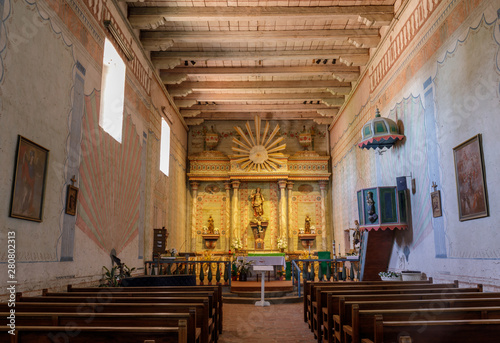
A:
[0,320,187,343]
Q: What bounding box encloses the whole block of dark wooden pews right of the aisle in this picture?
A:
[304,279,500,343]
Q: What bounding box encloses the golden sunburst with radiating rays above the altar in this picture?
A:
[232,116,286,172]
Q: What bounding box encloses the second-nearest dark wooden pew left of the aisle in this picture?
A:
[0,314,197,343]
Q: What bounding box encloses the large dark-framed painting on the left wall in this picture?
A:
[10,136,49,222]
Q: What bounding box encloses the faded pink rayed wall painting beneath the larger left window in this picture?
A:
[76,92,143,254]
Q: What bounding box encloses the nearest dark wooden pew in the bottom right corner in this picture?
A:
[370,315,500,343]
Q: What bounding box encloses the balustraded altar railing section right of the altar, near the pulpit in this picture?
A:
[291,258,359,297]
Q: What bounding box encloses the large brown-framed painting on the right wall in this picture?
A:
[453,134,489,221]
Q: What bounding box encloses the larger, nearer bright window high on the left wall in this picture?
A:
[99,38,126,143]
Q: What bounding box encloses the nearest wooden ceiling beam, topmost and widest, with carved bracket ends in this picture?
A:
[128,5,394,29]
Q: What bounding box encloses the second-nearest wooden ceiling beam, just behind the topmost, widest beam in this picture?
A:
[141,29,380,51]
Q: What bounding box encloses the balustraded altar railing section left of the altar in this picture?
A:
[144,259,231,285]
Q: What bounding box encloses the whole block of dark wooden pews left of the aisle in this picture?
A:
[0,285,223,343]
